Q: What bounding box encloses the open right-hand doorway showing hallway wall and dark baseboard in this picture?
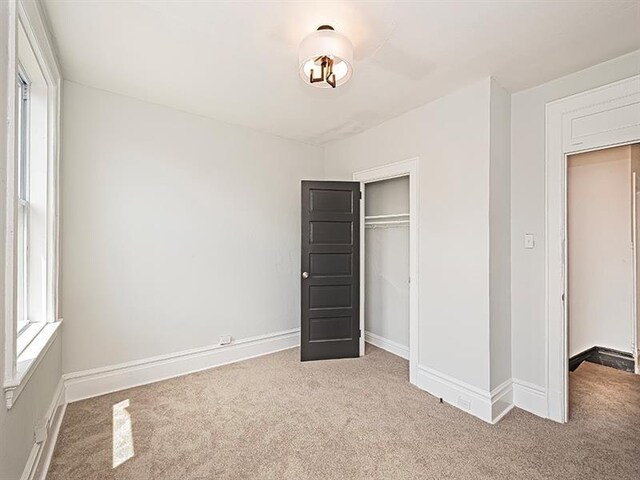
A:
[566,144,640,420]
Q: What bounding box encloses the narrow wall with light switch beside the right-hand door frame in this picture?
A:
[511,48,640,387]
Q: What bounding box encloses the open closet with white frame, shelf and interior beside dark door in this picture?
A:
[353,158,419,384]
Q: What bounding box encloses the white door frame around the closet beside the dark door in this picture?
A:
[353,157,420,384]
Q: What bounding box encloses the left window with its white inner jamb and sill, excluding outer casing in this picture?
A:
[14,17,51,357]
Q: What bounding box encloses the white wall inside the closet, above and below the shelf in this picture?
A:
[365,177,409,349]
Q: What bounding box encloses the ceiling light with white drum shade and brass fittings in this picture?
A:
[298,25,353,88]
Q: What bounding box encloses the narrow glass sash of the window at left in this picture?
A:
[16,66,30,340]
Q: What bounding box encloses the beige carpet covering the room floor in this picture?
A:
[48,347,640,480]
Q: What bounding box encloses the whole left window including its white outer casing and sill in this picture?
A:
[0,0,61,408]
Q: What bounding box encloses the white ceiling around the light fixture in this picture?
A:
[44,0,640,144]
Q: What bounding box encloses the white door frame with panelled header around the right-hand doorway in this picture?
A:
[545,75,640,423]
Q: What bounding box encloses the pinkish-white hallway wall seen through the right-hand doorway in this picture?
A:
[567,146,635,356]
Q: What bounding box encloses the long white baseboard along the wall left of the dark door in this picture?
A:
[63,328,300,402]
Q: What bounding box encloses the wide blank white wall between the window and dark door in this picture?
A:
[62,82,322,372]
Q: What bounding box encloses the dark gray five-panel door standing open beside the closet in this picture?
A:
[300,182,360,361]
